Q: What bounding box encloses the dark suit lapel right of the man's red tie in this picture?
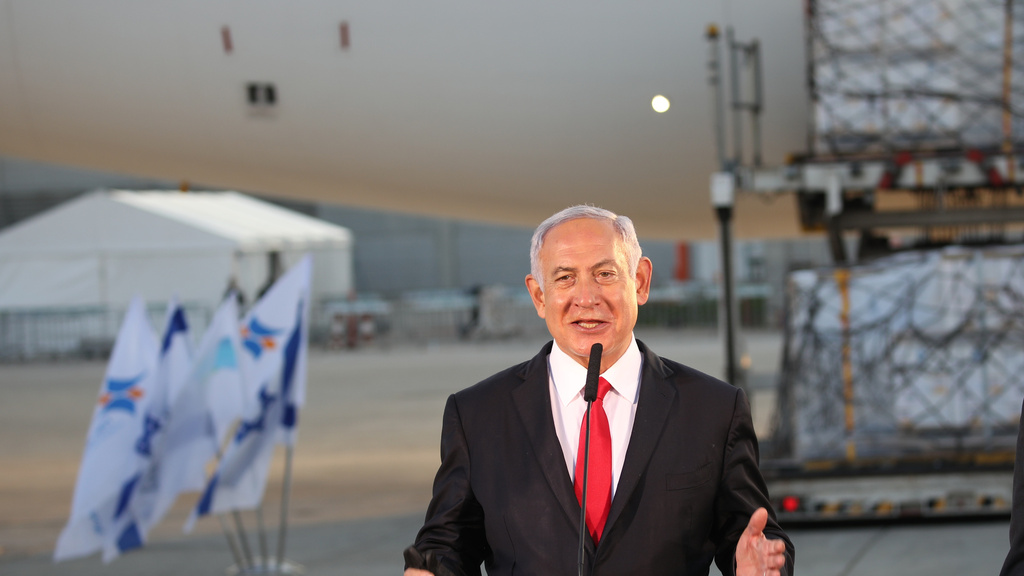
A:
[602,341,676,543]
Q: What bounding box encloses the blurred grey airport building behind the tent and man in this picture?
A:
[0,158,829,356]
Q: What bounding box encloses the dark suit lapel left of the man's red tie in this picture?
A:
[512,343,581,532]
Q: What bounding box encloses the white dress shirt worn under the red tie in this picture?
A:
[548,337,643,497]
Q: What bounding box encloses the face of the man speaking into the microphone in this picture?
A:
[526,218,651,371]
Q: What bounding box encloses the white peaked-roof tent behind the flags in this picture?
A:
[0,191,353,311]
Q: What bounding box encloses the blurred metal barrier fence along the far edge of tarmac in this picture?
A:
[0,283,774,362]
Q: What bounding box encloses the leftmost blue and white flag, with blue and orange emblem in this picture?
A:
[53,296,160,562]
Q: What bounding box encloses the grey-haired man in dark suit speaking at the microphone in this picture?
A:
[406,206,794,576]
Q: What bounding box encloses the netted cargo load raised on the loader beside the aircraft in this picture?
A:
[807,0,1024,155]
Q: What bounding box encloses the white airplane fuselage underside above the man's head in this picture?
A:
[0,0,807,238]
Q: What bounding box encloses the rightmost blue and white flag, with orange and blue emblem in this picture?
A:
[185,256,312,531]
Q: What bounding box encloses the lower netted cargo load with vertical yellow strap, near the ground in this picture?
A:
[775,246,1024,460]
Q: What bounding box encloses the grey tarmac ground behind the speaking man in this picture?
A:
[0,330,1009,576]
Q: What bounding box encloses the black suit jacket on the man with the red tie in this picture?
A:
[416,342,794,576]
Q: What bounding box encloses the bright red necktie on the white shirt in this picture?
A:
[574,378,611,544]
